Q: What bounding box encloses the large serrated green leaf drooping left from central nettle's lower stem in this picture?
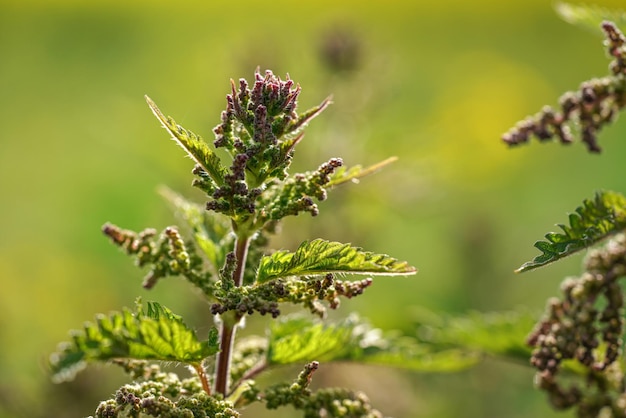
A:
[50,299,219,381]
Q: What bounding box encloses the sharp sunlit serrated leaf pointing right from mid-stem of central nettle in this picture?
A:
[257,239,417,283]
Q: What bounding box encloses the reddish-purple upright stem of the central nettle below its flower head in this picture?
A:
[215,237,250,397]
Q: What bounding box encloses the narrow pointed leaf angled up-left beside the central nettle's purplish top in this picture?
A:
[145,96,227,186]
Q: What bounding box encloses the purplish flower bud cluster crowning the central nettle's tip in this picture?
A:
[193,70,329,222]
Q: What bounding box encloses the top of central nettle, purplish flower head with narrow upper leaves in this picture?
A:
[147,70,395,232]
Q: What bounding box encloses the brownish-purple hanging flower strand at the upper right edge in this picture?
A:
[502,22,626,152]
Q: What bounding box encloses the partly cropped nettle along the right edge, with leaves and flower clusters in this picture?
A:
[502,4,626,417]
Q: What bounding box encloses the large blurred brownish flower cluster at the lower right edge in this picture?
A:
[528,234,626,416]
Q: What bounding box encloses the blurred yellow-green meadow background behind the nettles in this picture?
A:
[0,0,626,417]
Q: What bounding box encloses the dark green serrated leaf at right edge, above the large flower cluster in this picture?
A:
[516,191,626,273]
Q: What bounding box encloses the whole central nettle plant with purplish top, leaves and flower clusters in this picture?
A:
[50,71,420,417]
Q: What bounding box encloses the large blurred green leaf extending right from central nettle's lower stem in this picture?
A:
[267,316,478,372]
